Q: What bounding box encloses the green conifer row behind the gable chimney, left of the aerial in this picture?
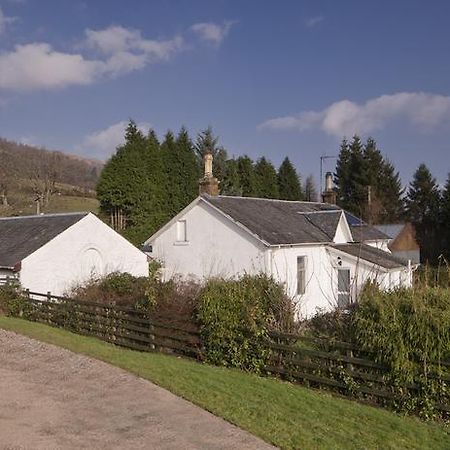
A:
[97,121,317,244]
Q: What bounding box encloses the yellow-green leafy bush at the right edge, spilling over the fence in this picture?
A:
[353,284,450,381]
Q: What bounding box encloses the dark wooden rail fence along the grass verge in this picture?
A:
[9,292,450,414]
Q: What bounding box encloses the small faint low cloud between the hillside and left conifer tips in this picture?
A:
[76,120,151,159]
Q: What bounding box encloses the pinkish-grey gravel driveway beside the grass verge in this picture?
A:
[0,330,273,450]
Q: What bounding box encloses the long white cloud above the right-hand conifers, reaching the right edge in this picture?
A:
[258,92,450,137]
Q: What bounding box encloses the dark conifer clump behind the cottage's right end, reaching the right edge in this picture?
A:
[334,136,450,264]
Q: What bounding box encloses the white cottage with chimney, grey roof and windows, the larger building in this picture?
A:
[144,156,412,317]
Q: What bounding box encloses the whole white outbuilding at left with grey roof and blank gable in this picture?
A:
[0,213,148,295]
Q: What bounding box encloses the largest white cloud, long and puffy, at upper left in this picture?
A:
[0,27,184,91]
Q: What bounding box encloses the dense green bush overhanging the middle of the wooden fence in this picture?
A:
[198,275,294,372]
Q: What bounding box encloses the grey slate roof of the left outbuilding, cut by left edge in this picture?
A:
[0,213,89,269]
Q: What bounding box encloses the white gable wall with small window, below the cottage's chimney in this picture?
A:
[149,201,266,280]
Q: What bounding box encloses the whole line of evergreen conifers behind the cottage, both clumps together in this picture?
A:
[97,121,450,263]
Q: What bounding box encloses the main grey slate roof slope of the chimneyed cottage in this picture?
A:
[203,195,342,245]
